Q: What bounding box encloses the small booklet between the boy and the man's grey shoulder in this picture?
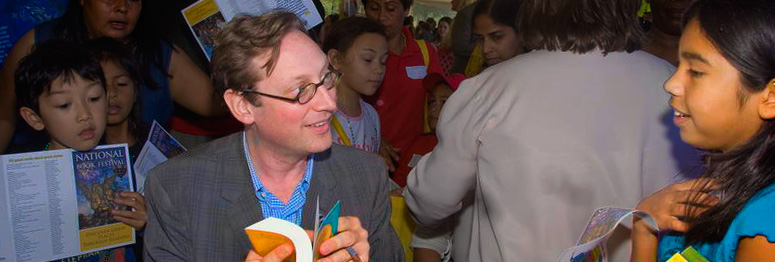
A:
[134,120,188,193]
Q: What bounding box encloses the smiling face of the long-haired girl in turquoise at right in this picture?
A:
[665,20,766,151]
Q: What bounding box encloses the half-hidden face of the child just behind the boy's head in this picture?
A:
[100,60,135,125]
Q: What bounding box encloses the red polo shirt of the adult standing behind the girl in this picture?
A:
[366,27,442,149]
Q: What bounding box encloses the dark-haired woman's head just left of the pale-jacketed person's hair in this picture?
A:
[472,0,525,67]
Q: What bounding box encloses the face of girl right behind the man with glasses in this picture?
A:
[339,33,388,96]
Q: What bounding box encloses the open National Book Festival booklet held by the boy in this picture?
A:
[0,144,135,262]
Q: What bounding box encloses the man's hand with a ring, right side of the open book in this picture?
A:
[318,216,369,262]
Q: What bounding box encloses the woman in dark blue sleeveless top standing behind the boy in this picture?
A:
[0,0,225,152]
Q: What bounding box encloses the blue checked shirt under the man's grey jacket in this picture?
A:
[242,131,315,225]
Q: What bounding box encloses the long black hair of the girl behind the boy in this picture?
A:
[85,37,148,140]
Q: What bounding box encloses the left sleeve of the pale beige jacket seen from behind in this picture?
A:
[404,76,484,224]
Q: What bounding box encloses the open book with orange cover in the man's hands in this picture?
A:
[245,202,341,262]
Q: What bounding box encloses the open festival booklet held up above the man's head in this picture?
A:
[181,0,323,60]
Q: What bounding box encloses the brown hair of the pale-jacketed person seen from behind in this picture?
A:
[517,0,644,54]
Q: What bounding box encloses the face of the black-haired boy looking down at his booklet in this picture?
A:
[25,73,107,151]
